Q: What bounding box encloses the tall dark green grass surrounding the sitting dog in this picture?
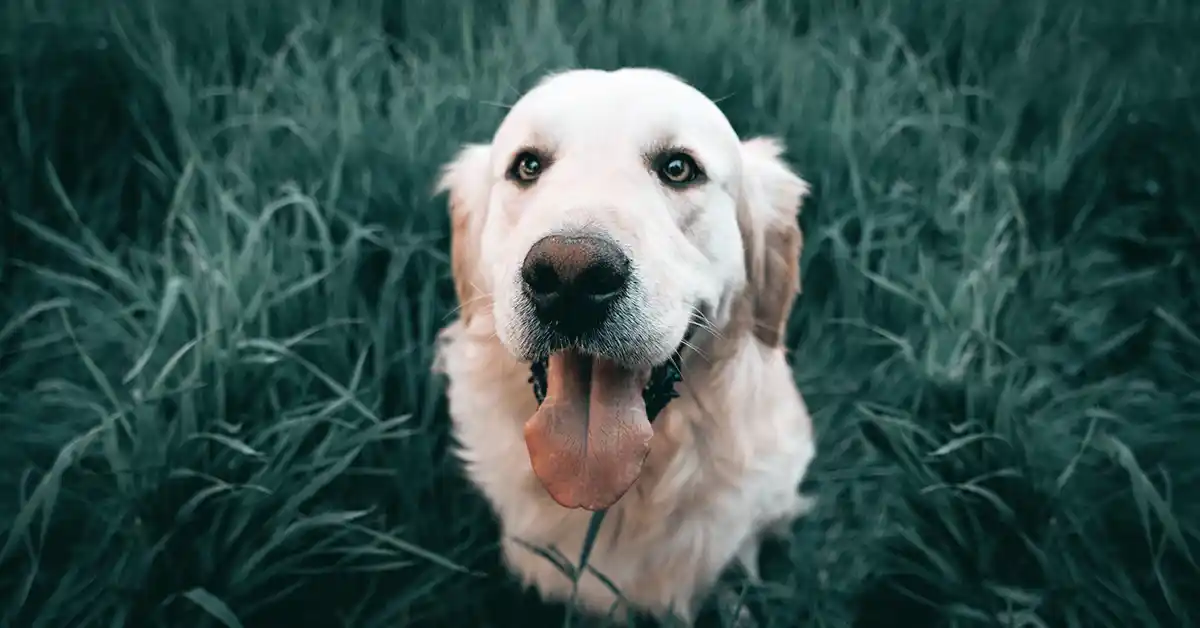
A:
[0,0,1200,628]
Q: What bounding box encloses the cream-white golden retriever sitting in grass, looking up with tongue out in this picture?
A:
[434,68,816,624]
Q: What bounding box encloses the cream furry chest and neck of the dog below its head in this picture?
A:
[440,329,812,612]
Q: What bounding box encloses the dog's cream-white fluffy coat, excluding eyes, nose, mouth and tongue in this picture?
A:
[437,68,815,622]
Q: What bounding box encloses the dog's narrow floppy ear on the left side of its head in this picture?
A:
[434,144,492,323]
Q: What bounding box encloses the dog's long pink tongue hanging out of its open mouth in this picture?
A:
[524,351,654,510]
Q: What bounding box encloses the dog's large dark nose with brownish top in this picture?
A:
[521,235,631,335]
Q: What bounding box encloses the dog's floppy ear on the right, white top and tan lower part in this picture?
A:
[738,138,809,347]
